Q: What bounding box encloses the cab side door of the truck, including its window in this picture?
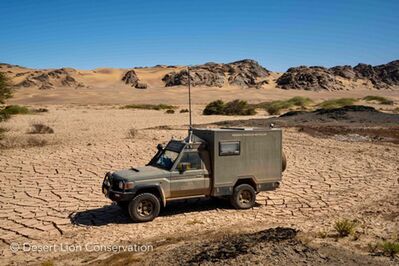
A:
[170,150,210,198]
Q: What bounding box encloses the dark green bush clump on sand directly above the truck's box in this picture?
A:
[202,100,256,115]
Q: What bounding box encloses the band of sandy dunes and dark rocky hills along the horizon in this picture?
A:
[0,59,399,91]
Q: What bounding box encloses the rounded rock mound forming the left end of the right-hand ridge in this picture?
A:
[277,66,344,91]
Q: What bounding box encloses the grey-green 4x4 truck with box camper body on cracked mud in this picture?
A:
[102,128,286,222]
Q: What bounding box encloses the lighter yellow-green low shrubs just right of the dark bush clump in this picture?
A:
[256,96,313,115]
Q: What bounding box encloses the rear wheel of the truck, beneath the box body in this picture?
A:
[230,184,256,209]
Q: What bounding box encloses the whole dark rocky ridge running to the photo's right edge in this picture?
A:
[277,60,399,91]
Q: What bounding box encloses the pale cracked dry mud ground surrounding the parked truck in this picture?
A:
[0,106,399,264]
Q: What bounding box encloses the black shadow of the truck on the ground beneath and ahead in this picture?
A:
[69,198,260,226]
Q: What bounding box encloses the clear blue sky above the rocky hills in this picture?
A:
[0,0,399,71]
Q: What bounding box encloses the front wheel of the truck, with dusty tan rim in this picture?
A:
[128,193,161,223]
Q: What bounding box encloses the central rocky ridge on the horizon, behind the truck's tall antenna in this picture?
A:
[162,59,270,87]
